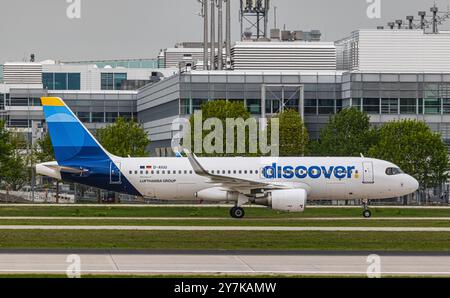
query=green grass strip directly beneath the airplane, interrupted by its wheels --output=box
[0,205,450,218]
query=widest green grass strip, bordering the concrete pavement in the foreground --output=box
[0,230,450,252]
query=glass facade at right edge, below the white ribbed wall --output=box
[343,73,450,115]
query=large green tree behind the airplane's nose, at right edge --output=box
[369,120,449,190]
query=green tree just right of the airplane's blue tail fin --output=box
[97,117,150,157]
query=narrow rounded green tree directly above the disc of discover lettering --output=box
[274,109,309,156]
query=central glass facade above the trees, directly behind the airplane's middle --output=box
[180,74,343,115]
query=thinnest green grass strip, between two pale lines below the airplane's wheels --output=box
[0,218,450,229]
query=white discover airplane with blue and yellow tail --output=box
[36,97,419,218]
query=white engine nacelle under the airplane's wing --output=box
[268,189,308,212]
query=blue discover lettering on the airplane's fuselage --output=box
[262,163,359,179]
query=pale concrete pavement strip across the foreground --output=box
[0,250,450,276]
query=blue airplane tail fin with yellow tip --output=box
[41,97,109,165]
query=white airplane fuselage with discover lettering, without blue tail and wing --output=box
[111,157,418,200]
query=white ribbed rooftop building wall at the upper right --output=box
[336,29,450,73]
